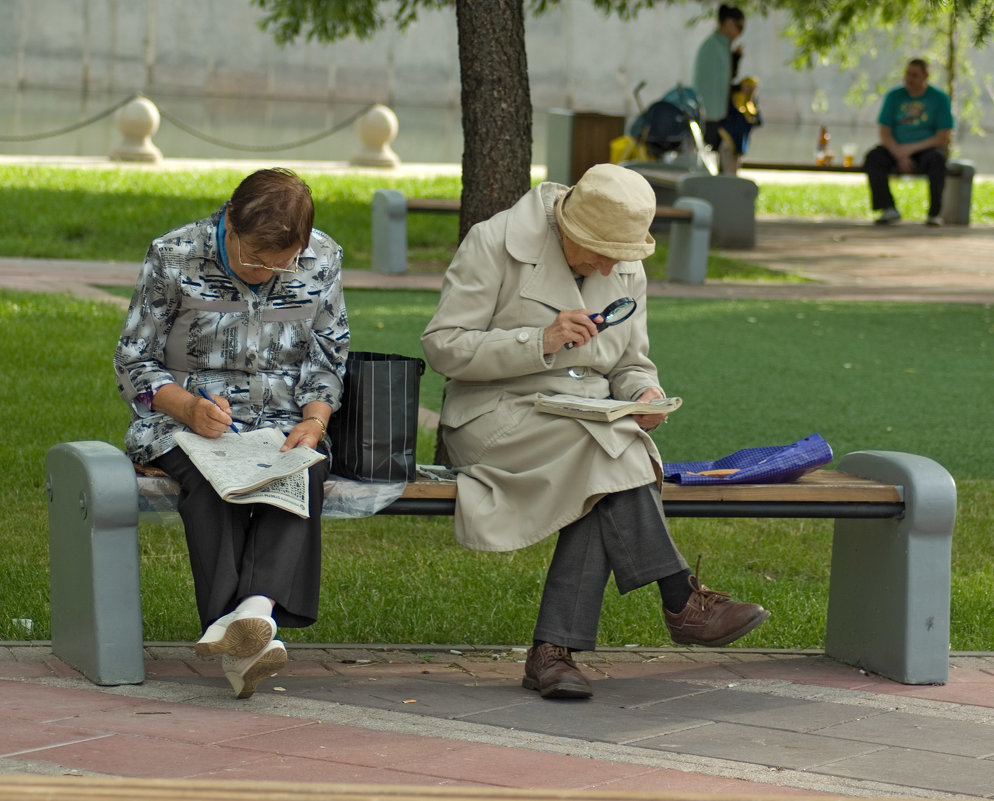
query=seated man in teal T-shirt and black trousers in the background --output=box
[864,58,954,225]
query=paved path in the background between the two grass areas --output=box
[0,219,994,304]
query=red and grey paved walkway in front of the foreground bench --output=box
[0,643,994,799]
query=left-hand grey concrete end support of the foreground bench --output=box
[45,442,145,684]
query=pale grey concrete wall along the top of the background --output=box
[0,0,994,125]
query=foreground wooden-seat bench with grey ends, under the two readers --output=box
[45,442,956,684]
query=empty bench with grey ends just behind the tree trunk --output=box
[372,189,712,284]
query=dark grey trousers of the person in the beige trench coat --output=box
[535,484,687,651]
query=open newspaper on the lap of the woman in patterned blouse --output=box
[175,428,325,518]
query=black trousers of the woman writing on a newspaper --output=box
[153,448,329,629]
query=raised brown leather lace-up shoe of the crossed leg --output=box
[663,576,770,648]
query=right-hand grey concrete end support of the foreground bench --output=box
[825,451,956,684]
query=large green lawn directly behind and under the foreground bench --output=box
[0,291,994,650]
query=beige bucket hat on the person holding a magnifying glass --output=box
[556,164,656,261]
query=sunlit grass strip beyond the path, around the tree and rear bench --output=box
[0,166,799,281]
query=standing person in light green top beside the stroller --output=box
[693,3,745,167]
